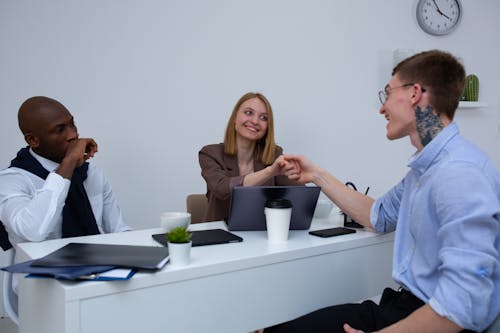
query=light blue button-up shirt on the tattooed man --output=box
[370,123,500,331]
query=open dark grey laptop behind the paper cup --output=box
[227,186,321,231]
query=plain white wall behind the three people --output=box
[0,0,500,228]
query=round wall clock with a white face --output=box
[417,0,462,36]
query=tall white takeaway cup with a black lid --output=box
[264,199,292,243]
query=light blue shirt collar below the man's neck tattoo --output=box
[408,122,459,174]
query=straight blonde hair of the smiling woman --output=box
[224,92,276,165]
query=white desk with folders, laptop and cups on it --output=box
[18,220,393,333]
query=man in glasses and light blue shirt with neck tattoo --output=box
[266,50,500,333]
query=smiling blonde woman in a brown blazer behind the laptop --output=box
[199,92,299,221]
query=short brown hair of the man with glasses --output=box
[392,50,465,119]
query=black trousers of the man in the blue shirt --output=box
[264,288,476,333]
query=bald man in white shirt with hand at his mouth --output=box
[0,96,130,249]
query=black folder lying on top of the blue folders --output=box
[32,243,168,270]
